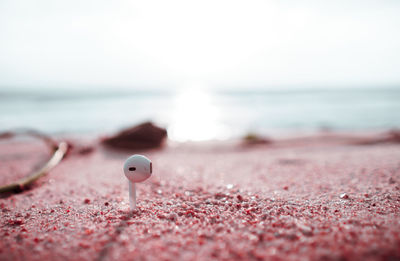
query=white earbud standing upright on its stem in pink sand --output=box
[124,155,153,210]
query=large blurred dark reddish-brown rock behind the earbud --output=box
[102,122,167,150]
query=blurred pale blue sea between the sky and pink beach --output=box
[0,88,400,141]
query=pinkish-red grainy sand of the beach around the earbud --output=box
[0,135,400,260]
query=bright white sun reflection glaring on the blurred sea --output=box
[168,88,226,141]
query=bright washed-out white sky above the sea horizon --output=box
[0,0,400,88]
